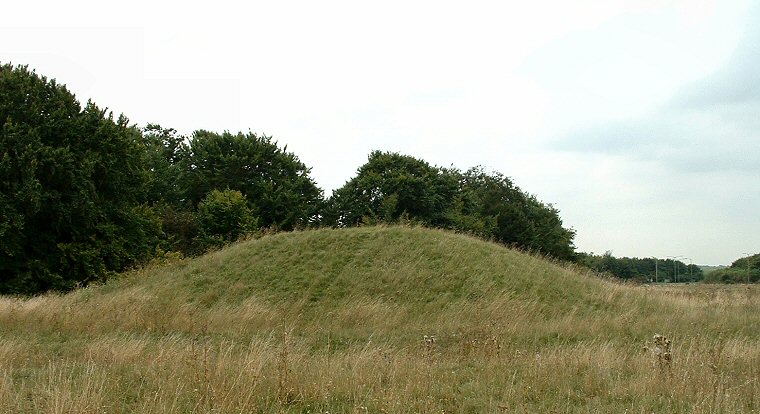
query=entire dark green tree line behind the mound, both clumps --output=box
[0,64,588,294]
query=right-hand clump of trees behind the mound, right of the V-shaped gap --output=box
[324,151,575,260]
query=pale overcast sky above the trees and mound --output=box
[0,0,760,264]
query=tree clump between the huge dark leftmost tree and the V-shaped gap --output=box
[138,124,323,255]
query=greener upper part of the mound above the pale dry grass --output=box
[114,227,624,313]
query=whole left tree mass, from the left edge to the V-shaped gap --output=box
[0,65,323,293]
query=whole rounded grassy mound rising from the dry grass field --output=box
[2,226,656,347]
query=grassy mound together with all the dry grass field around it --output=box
[0,227,760,413]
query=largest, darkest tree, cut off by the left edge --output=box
[0,65,160,293]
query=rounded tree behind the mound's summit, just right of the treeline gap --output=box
[324,151,457,227]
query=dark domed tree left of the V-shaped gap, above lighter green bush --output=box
[182,130,323,230]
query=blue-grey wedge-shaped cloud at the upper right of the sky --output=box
[551,2,760,174]
